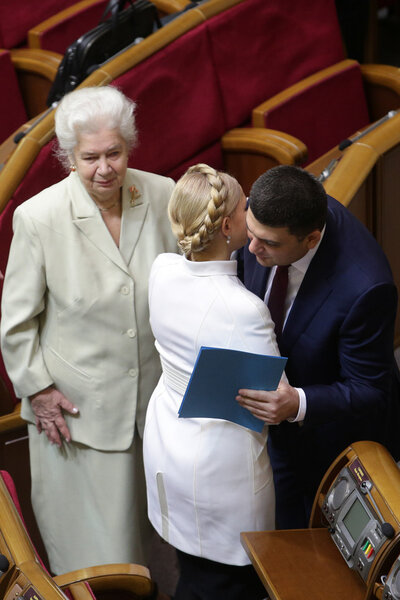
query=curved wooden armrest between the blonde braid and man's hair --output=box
[221,127,307,194]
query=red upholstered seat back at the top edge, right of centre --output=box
[205,0,344,129]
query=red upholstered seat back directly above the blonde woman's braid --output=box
[113,23,226,174]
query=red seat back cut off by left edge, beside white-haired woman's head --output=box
[0,50,28,144]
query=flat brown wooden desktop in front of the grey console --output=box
[241,529,366,600]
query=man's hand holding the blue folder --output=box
[236,381,299,425]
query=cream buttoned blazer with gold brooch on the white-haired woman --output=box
[1,169,176,450]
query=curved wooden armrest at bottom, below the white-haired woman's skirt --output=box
[54,563,155,598]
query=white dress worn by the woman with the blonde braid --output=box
[144,254,279,565]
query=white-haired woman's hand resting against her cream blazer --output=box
[30,386,79,447]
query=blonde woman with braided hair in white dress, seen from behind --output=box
[144,164,278,600]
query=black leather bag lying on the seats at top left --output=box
[47,0,161,106]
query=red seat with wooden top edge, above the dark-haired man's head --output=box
[253,60,370,162]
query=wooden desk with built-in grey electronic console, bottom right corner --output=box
[242,442,400,600]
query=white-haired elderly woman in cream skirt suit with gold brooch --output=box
[1,87,176,573]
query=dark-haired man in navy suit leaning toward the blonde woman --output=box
[237,166,400,528]
